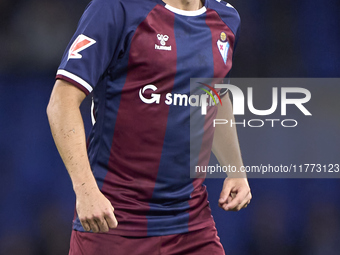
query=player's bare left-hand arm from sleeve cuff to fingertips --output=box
[47,80,118,232]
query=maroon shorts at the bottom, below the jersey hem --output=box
[69,226,225,255]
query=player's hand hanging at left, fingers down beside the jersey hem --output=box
[76,185,118,233]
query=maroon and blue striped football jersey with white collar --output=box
[57,0,240,236]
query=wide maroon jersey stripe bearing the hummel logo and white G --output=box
[102,5,177,235]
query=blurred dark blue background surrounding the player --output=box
[0,0,340,255]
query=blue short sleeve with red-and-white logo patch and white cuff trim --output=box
[56,0,124,95]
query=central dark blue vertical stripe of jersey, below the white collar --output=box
[147,11,213,235]
